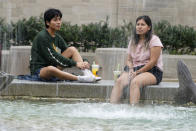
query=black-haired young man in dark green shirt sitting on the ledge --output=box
[30,9,101,82]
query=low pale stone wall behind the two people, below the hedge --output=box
[1,46,196,82]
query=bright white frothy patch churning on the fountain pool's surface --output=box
[68,103,186,121]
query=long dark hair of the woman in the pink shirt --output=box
[132,15,152,49]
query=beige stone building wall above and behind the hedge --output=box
[0,0,196,28]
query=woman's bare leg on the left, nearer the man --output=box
[110,72,129,103]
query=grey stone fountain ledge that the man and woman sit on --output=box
[0,79,179,102]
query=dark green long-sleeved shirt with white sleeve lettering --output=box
[30,30,76,74]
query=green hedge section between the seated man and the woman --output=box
[59,19,132,52]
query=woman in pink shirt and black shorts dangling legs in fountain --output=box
[110,16,163,104]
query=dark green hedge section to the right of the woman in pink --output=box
[154,21,196,54]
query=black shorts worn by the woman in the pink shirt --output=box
[124,65,163,85]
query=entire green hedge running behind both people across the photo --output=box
[0,16,196,55]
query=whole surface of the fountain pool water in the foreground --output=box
[0,100,196,131]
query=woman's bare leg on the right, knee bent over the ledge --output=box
[130,72,157,104]
